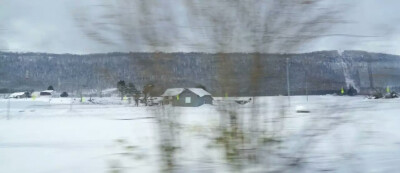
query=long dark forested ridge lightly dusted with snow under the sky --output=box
[0,51,400,96]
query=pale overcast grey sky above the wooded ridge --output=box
[0,0,400,54]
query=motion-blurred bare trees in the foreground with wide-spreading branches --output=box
[75,0,360,172]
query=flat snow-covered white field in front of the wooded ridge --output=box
[0,96,400,173]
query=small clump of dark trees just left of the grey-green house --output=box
[117,80,154,106]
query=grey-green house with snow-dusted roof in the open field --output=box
[161,88,213,107]
